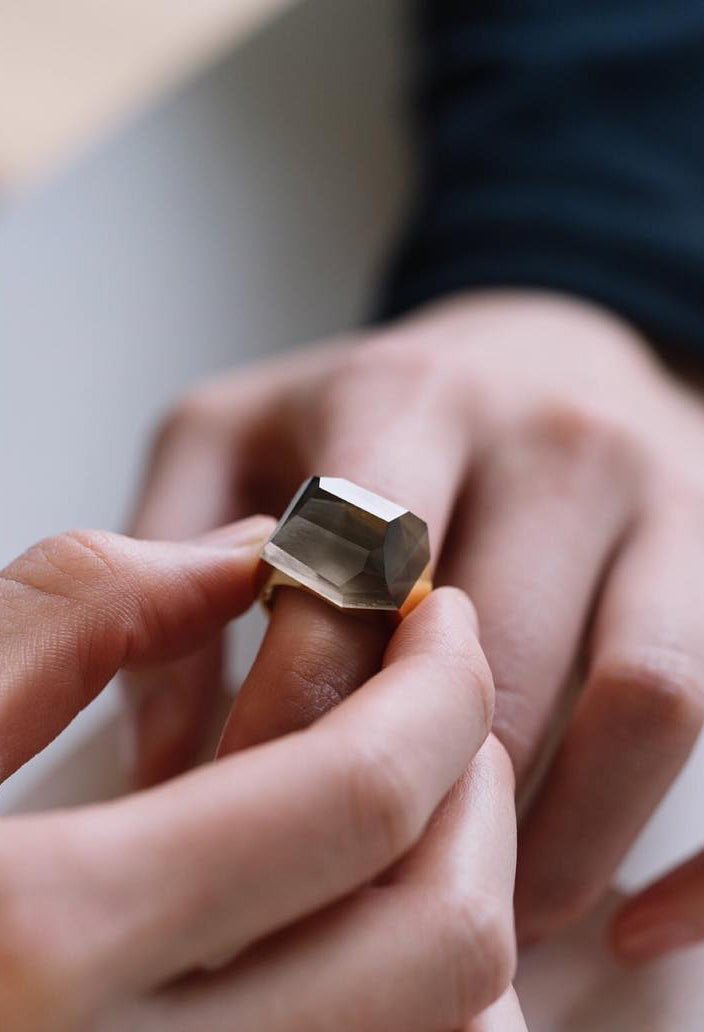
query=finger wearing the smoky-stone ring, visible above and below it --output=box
[220,346,471,752]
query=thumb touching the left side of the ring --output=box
[0,517,271,778]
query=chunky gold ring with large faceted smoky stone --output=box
[259,477,433,620]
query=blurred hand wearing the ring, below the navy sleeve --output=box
[129,291,704,938]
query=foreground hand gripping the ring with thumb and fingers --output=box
[0,519,524,1032]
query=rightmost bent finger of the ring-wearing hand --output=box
[516,504,704,938]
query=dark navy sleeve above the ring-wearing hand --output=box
[382,0,704,360]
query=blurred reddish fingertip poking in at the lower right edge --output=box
[611,853,704,964]
